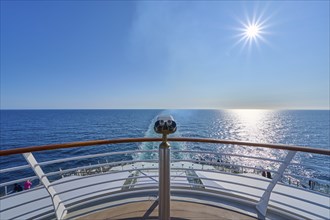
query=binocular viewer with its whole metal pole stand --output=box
[154,115,176,220]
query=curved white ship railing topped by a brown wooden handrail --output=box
[0,138,330,219]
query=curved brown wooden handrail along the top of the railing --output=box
[0,137,330,156]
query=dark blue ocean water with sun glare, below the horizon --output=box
[0,110,330,186]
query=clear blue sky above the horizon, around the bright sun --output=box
[1,1,329,109]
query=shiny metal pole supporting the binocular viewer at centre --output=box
[158,134,171,220]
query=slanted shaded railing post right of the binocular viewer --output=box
[256,151,296,218]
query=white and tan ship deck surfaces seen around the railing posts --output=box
[0,162,330,219]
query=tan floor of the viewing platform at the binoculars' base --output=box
[79,201,255,220]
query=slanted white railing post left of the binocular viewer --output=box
[23,153,67,219]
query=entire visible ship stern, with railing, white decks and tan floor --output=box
[0,138,330,220]
